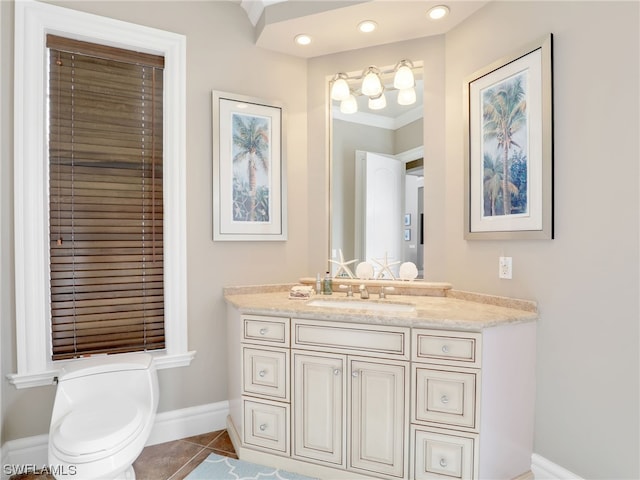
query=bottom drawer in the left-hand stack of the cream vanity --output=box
[243,398,289,455]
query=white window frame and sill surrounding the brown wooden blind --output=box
[8,2,195,388]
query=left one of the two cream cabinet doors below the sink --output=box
[293,351,346,467]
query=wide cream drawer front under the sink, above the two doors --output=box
[293,319,410,360]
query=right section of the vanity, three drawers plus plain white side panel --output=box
[410,323,535,480]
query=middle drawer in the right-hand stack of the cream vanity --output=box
[412,365,479,428]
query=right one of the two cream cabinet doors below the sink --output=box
[349,357,409,478]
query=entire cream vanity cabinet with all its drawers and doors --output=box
[227,293,536,480]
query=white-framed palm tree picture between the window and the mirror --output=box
[212,90,287,241]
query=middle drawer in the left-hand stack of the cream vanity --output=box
[242,346,289,401]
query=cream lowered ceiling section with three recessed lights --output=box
[240,0,488,58]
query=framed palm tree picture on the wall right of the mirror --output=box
[464,34,553,240]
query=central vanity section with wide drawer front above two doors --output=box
[291,319,410,478]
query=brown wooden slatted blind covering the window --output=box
[47,35,165,360]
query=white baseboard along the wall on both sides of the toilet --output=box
[0,400,229,479]
